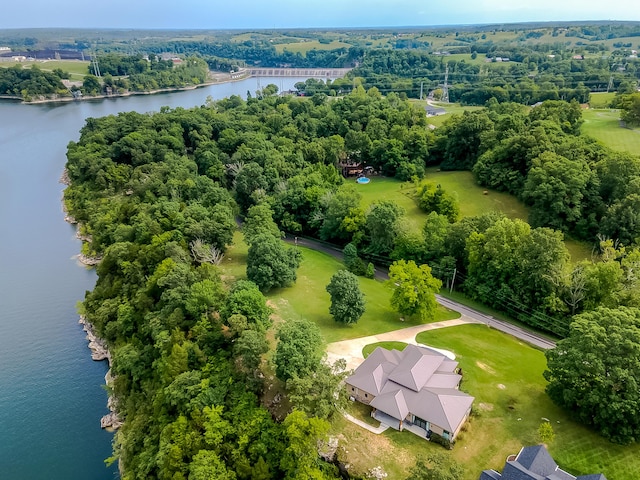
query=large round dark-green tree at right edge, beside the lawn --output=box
[544,307,640,443]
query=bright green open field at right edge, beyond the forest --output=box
[582,110,640,155]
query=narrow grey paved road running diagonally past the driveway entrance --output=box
[284,234,556,350]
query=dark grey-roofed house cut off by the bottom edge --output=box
[480,445,607,480]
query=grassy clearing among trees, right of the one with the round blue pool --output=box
[426,168,529,220]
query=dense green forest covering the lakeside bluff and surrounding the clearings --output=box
[65,86,640,479]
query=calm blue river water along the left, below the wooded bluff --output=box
[0,78,304,480]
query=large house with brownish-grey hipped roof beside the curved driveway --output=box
[345,345,473,441]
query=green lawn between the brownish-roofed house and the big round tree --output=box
[408,325,640,480]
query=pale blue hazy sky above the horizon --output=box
[0,0,640,29]
